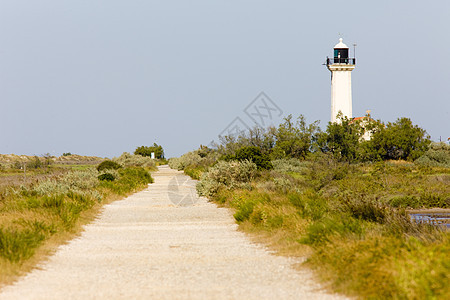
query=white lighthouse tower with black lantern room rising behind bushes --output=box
[327,38,356,122]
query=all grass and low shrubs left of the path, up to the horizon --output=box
[0,153,155,285]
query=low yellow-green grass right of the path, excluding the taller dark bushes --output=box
[186,156,450,299]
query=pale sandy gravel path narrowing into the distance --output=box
[0,167,348,300]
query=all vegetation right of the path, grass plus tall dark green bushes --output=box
[169,117,450,299]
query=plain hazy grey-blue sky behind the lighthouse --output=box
[0,0,450,157]
